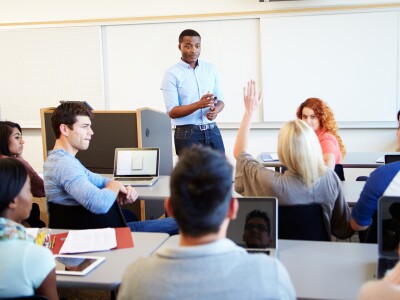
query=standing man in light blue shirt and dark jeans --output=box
[161,29,225,155]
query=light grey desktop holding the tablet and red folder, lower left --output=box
[53,230,169,291]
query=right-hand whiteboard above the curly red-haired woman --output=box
[260,12,399,127]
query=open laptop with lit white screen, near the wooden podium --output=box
[114,148,160,186]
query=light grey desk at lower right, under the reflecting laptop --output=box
[161,236,378,299]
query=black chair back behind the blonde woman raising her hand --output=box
[278,203,331,241]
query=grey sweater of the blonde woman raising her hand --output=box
[235,153,354,239]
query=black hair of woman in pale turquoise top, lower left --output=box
[0,157,28,214]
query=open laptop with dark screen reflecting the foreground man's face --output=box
[227,197,278,256]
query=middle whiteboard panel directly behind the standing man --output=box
[103,19,260,122]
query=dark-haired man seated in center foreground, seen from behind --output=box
[118,146,295,300]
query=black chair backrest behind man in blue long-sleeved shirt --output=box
[47,201,127,229]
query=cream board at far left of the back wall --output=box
[0,26,104,128]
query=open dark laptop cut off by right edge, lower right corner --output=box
[377,196,400,278]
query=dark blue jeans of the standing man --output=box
[174,123,225,155]
